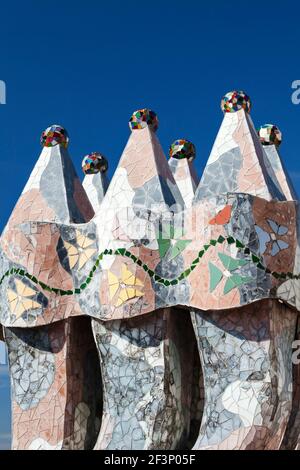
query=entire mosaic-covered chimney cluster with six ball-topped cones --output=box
[0,91,300,450]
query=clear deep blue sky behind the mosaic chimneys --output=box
[0,0,300,448]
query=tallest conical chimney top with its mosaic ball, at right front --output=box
[194,91,285,203]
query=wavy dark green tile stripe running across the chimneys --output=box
[0,235,300,295]
